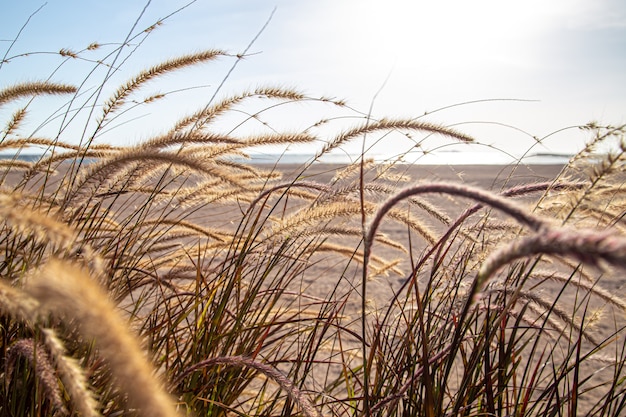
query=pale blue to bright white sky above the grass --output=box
[0,0,626,162]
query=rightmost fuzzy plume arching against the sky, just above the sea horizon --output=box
[316,119,474,158]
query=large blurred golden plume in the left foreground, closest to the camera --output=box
[27,260,177,417]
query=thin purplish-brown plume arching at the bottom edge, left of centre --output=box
[174,356,321,417]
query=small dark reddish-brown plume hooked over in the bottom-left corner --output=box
[5,339,68,415]
